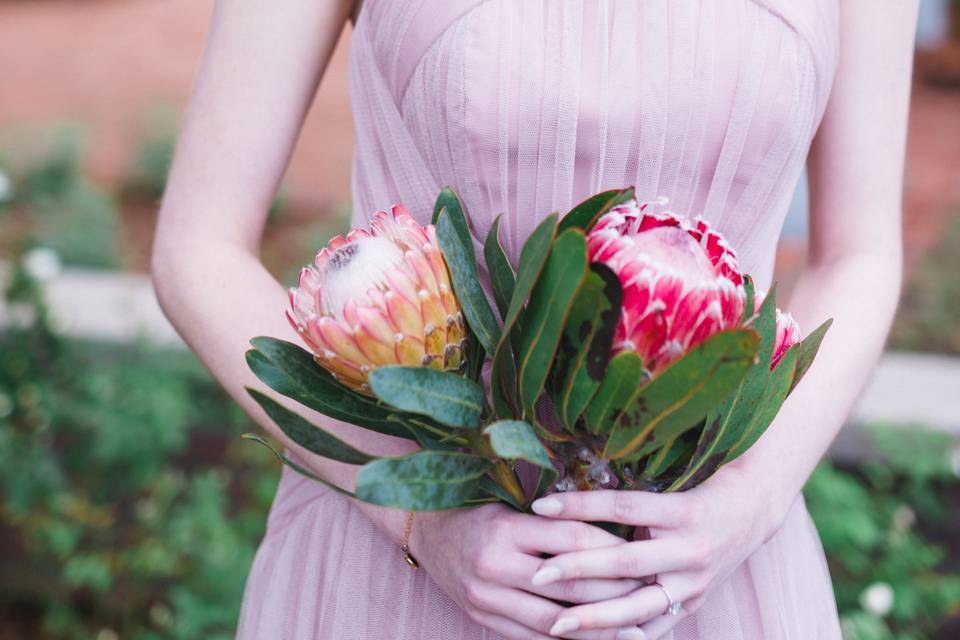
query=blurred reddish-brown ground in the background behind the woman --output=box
[0,0,960,262]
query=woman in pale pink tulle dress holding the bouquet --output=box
[154,0,917,640]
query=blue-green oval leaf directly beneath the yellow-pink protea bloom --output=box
[368,366,484,428]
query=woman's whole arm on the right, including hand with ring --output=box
[534,0,917,640]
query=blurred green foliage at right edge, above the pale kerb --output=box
[890,213,960,354]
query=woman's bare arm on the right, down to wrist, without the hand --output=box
[738,0,918,515]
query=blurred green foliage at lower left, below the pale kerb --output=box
[0,252,277,640]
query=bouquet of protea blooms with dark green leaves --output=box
[247,188,830,510]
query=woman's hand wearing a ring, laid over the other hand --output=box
[533,466,789,640]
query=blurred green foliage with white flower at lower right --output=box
[805,427,960,640]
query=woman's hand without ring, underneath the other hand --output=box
[410,505,640,640]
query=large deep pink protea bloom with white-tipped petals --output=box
[587,201,746,375]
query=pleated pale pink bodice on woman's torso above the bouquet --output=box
[350,0,837,286]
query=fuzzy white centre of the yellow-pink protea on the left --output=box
[320,236,403,319]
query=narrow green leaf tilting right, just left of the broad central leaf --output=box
[490,213,557,418]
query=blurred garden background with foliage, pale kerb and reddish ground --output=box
[0,0,960,640]
